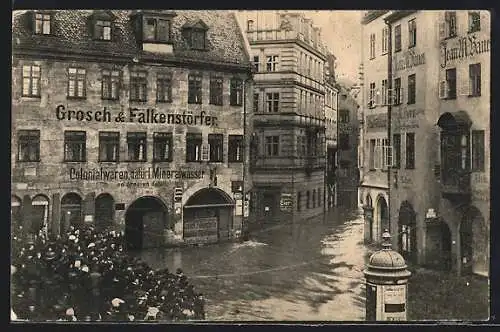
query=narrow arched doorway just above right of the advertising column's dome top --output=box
[398,201,417,263]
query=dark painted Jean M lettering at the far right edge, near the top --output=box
[441,35,491,68]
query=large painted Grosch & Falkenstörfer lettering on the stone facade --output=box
[56,105,218,127]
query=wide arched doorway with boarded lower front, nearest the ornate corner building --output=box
[183,188,234,243]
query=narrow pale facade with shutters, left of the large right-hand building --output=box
[359,10,389,242]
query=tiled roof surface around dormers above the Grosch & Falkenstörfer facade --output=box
[12,10,250,66]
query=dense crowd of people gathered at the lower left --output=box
[11,225,205,321]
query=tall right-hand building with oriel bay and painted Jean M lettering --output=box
[367,11,490,275]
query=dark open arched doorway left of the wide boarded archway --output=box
[125,196,168,250]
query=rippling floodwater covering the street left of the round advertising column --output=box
[140,211,366,321]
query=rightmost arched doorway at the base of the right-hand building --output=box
[460,206,489,275]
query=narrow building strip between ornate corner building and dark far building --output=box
[325,53,338,209]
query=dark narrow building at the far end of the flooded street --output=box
[337,85,360,208]
